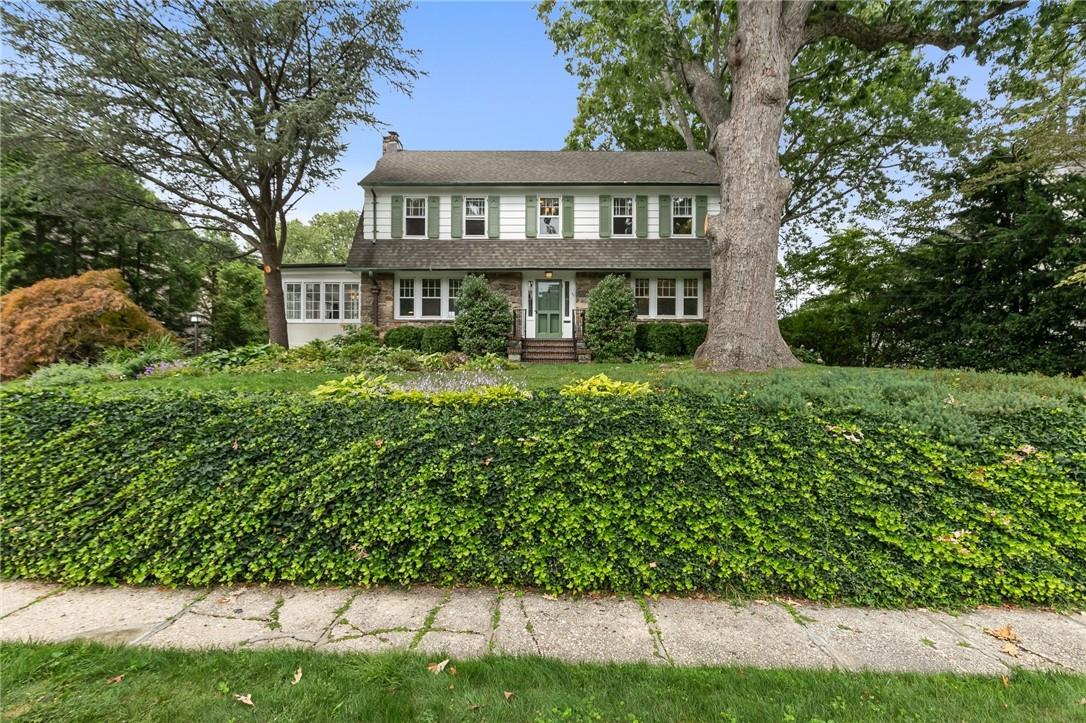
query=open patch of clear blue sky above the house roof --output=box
[292,0,578,220]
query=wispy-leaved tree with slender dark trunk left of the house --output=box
[0,0,417,345]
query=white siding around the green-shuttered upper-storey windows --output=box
[366,186,720,241]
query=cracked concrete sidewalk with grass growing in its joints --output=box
[0,581,1086,675]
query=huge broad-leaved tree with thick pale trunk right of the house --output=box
[540,0,1025,370]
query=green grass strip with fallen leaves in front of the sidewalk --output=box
[0,643,1086,723]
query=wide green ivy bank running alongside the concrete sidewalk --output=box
[0,390,1086,606]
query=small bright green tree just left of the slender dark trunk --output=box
[211,261,267,348]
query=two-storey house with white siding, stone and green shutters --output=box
[283,132,720,358]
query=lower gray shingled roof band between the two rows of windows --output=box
[346,238,709,271]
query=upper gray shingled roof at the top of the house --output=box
[359,151,720,186]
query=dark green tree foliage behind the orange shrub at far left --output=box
[0,144,238,330]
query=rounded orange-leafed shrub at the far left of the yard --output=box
[0,269,165,379]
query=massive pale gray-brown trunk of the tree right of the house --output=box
[695,2,799,371]
